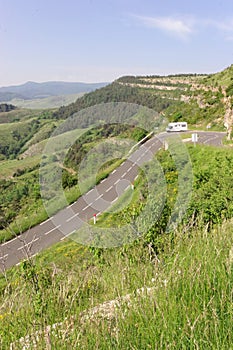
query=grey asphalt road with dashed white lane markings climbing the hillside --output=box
[0,131,225,272]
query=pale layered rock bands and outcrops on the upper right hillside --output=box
[119,74,233,133]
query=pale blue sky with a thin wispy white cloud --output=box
[0,0,233,86]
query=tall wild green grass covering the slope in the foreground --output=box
[0,223,233,349]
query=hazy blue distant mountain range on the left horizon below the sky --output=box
[0,81,108,102]
